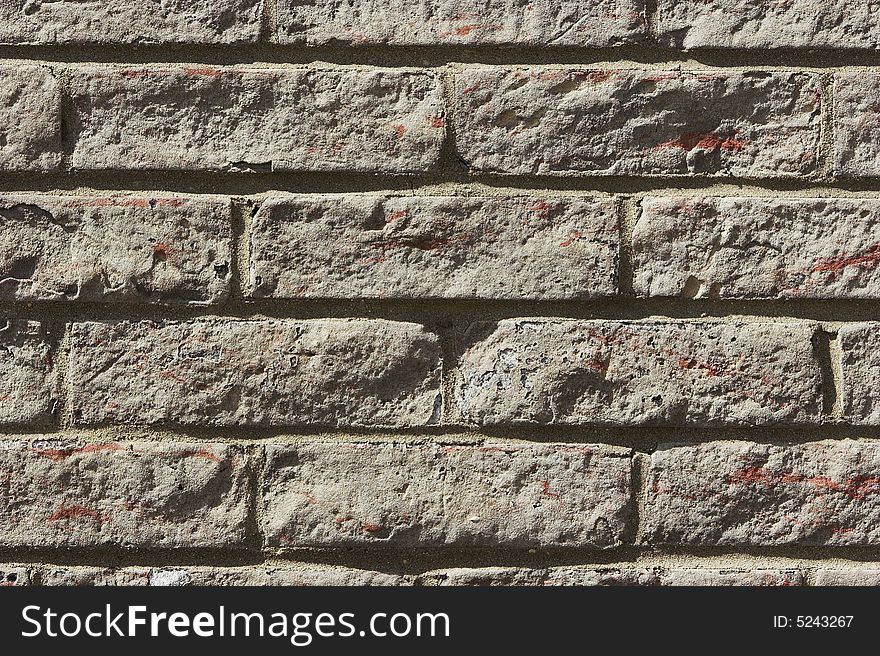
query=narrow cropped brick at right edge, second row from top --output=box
[834,71,880,178]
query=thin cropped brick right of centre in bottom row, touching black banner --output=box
[421,567,803,586]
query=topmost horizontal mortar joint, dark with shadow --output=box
[6,42,880,70]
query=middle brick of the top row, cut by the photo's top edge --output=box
[278,0,647,47]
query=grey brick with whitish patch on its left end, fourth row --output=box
[455,319,820,426]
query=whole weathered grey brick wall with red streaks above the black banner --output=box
[0,0,880,585]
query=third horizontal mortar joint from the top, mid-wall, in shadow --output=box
[0,296,880,322]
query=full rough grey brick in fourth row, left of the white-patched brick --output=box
[70,319,440,428]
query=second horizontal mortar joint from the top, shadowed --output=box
[0,170,880,200]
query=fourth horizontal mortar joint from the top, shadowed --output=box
[0,422,880,456]
